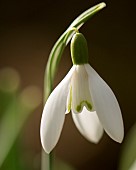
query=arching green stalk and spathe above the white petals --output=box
[44,2,106,98]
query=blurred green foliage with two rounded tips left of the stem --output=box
[0,68,41,170]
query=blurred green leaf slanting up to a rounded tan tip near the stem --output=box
[0,86,41,167]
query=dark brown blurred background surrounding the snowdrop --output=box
[0,0,136,170]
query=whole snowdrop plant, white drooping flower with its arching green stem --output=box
[40,2,124,170]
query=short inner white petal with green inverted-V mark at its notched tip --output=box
[71,65,93,113]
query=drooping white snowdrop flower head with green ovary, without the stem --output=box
[40,33,124,153]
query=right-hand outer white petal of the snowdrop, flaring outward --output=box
[85,64,124,143]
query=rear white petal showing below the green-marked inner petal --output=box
[72,107,103,143]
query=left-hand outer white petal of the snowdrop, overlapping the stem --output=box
[40,66,74,153]
